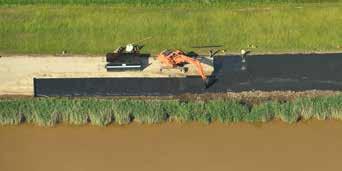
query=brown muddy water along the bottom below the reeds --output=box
[0,121,342,171]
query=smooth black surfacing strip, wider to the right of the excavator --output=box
[34,53,342,96]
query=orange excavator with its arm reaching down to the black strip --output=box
[157,50,208,87]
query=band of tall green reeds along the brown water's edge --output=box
[0,95,342,126]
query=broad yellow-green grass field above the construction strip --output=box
[0,2,342,54]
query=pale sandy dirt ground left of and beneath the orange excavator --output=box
[0,56,213,95]
